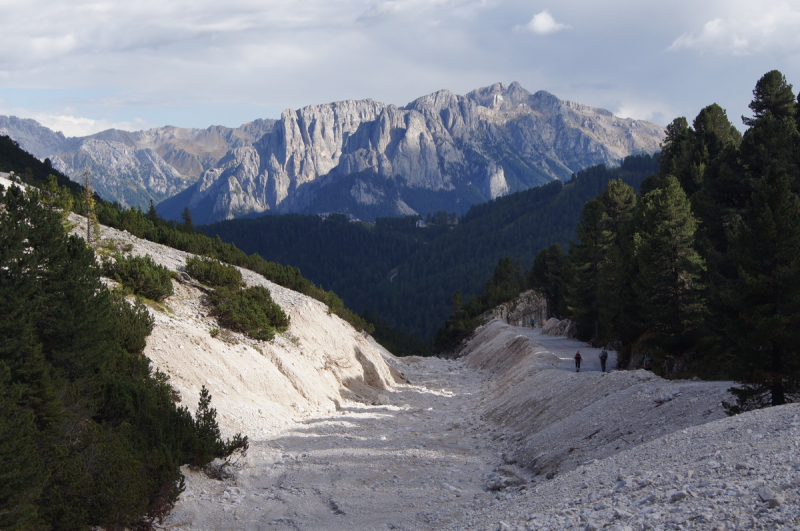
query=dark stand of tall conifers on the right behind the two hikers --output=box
[532,70,800,411]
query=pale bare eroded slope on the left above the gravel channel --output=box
[61,210,405,439]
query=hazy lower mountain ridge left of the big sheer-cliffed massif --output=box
[0,116,275,206]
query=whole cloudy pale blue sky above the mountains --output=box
[0,0,800,136]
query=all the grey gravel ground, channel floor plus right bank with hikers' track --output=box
[159,322,800,530]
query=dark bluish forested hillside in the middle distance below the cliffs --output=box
[201,155,658,340]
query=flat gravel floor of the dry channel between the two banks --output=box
[167,358,500,530]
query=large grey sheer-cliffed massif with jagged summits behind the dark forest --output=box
[159,83,664,223]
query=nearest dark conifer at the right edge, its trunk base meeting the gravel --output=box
[727,168,800,409]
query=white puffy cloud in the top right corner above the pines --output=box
[667,2,800,56]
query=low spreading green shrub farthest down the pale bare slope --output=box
[209,286,289,341]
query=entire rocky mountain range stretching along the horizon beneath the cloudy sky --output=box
[0,82,664,223]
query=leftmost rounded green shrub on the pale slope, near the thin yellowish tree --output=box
[103,254,173,302]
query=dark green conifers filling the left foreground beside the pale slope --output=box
[0,186,248,529]
